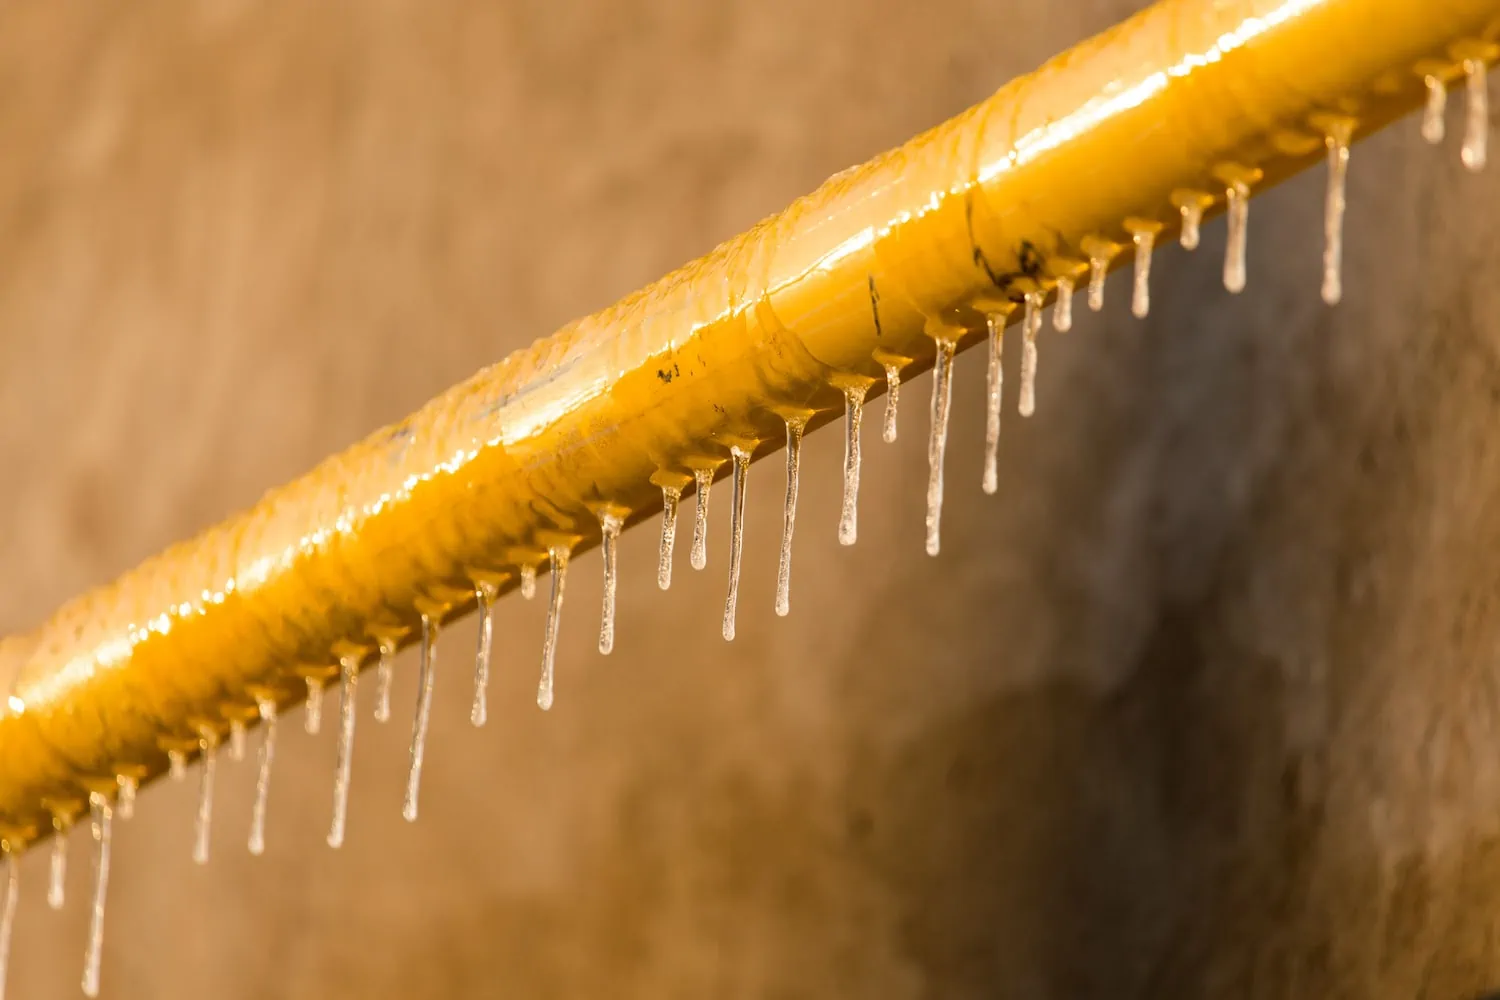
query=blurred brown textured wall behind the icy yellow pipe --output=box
[0,0,1500,1000]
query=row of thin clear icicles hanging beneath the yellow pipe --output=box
[0,60,1490,1000]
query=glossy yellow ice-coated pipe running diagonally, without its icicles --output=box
[0,0,1500,846]
